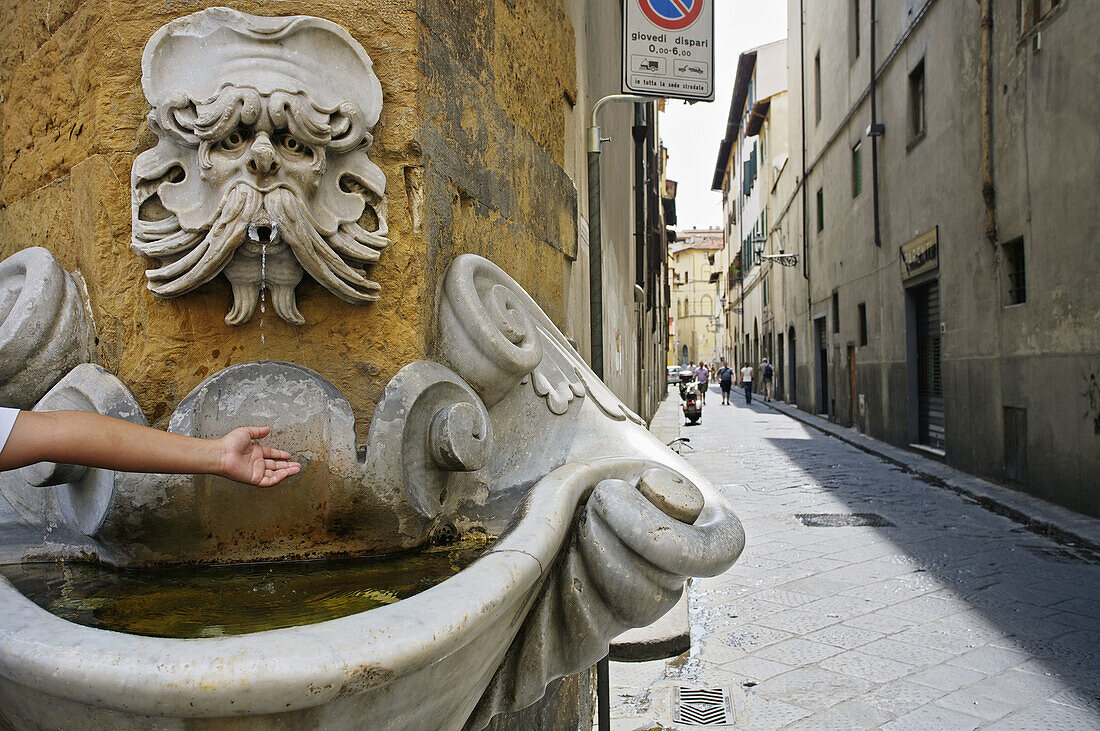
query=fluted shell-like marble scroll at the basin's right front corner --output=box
[465,458,745,731]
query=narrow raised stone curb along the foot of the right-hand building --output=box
[755,399,1100,552]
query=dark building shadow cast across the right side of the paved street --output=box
[756,433,1100,703]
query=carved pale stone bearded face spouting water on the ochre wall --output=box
[131,8,389,325]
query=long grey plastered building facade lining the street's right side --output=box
[708,0,1100,514]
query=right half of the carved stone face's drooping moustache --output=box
[264,188,381,304]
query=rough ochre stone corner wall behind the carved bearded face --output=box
[0,0,576,439]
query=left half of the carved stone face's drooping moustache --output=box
[142,184,263,297]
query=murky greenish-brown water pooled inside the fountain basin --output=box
[0,533,487,639]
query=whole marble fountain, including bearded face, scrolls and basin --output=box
[0,9,745,729]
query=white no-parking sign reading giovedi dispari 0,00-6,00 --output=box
[623,0,714,101]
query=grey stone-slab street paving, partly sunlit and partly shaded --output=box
[611,384,1100,730]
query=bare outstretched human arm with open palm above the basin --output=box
[0,411,301,487]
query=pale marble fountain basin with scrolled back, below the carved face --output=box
[0,248,745,730]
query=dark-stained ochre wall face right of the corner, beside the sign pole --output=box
[418,0,578,338]
